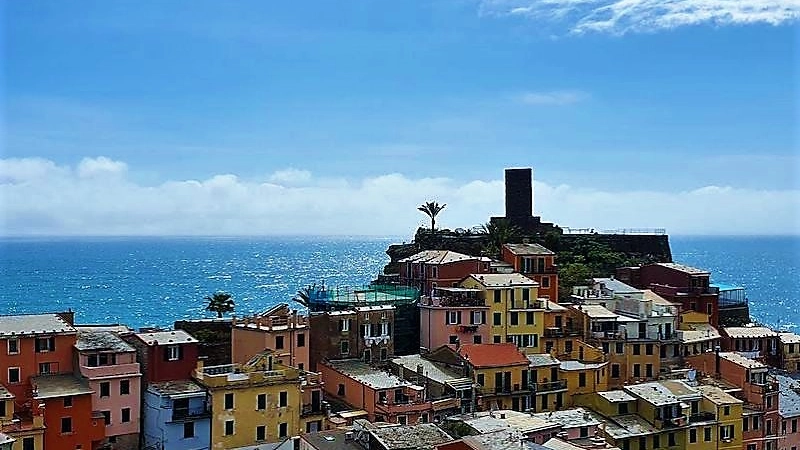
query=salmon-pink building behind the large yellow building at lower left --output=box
[231,303,310,370]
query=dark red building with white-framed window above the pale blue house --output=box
[123,330,199,383]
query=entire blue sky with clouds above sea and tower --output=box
[0,0,800,236]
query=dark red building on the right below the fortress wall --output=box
[616,263,719,327]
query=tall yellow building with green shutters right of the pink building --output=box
[461,273,549,354]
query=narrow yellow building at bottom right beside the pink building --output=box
[692,385,744,450]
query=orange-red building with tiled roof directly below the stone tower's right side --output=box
[502,244,558,301]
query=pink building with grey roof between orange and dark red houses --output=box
[75,331,142,450]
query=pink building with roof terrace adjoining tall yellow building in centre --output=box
[419,287,490,349]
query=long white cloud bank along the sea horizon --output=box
[0,156,800,236]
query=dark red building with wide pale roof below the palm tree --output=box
[399,250,491,295]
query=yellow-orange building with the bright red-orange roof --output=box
[456,343,531,411]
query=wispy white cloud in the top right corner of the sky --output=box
[481,0,800,35]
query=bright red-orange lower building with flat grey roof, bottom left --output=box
[31,374,105,450]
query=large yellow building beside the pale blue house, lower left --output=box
[194,352,305,449]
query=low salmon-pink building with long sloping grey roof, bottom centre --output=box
[317,359,433,425]
